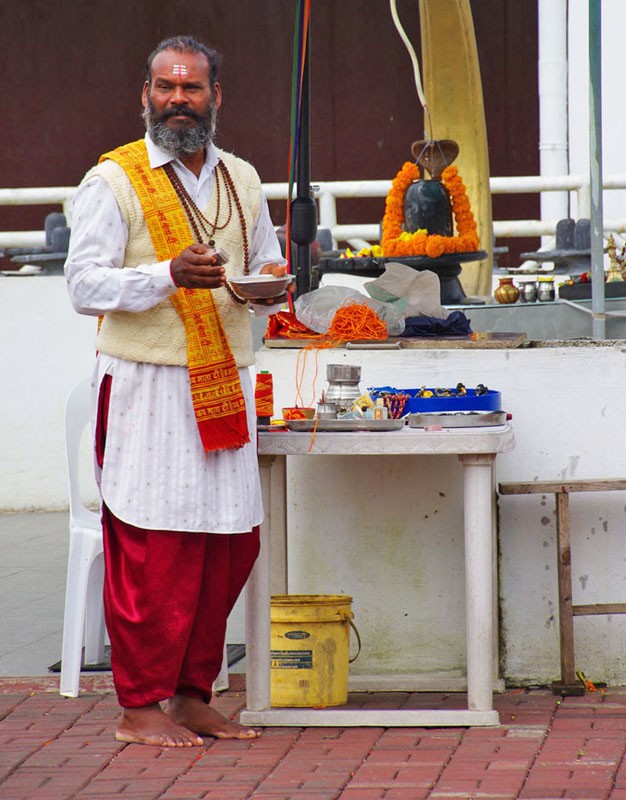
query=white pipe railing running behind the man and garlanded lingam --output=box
[0,175,626,248]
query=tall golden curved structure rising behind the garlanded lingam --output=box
[419,0,493,296]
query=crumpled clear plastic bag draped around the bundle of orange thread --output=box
[294,286,404,336]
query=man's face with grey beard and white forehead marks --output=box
[142,50,222,157]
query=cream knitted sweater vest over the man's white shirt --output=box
[90,150,261,367]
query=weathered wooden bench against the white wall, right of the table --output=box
[498,478,626,695]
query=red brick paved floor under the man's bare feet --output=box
[0,675,626,800]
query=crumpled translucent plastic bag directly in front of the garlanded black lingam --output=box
[365,261,448,319]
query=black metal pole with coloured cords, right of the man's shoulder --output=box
[291,23,317,295]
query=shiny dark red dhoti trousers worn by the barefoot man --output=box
[96,376,259,708]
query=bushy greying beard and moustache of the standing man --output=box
[142,98,217,158]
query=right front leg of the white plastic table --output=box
[459,453,495,711]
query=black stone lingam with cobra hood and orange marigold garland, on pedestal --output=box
[318,139,487,305]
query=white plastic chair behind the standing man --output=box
[59,378,229,697]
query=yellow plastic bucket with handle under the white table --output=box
[270,594,361,707]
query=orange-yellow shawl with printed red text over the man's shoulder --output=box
[100,139,250,452]
